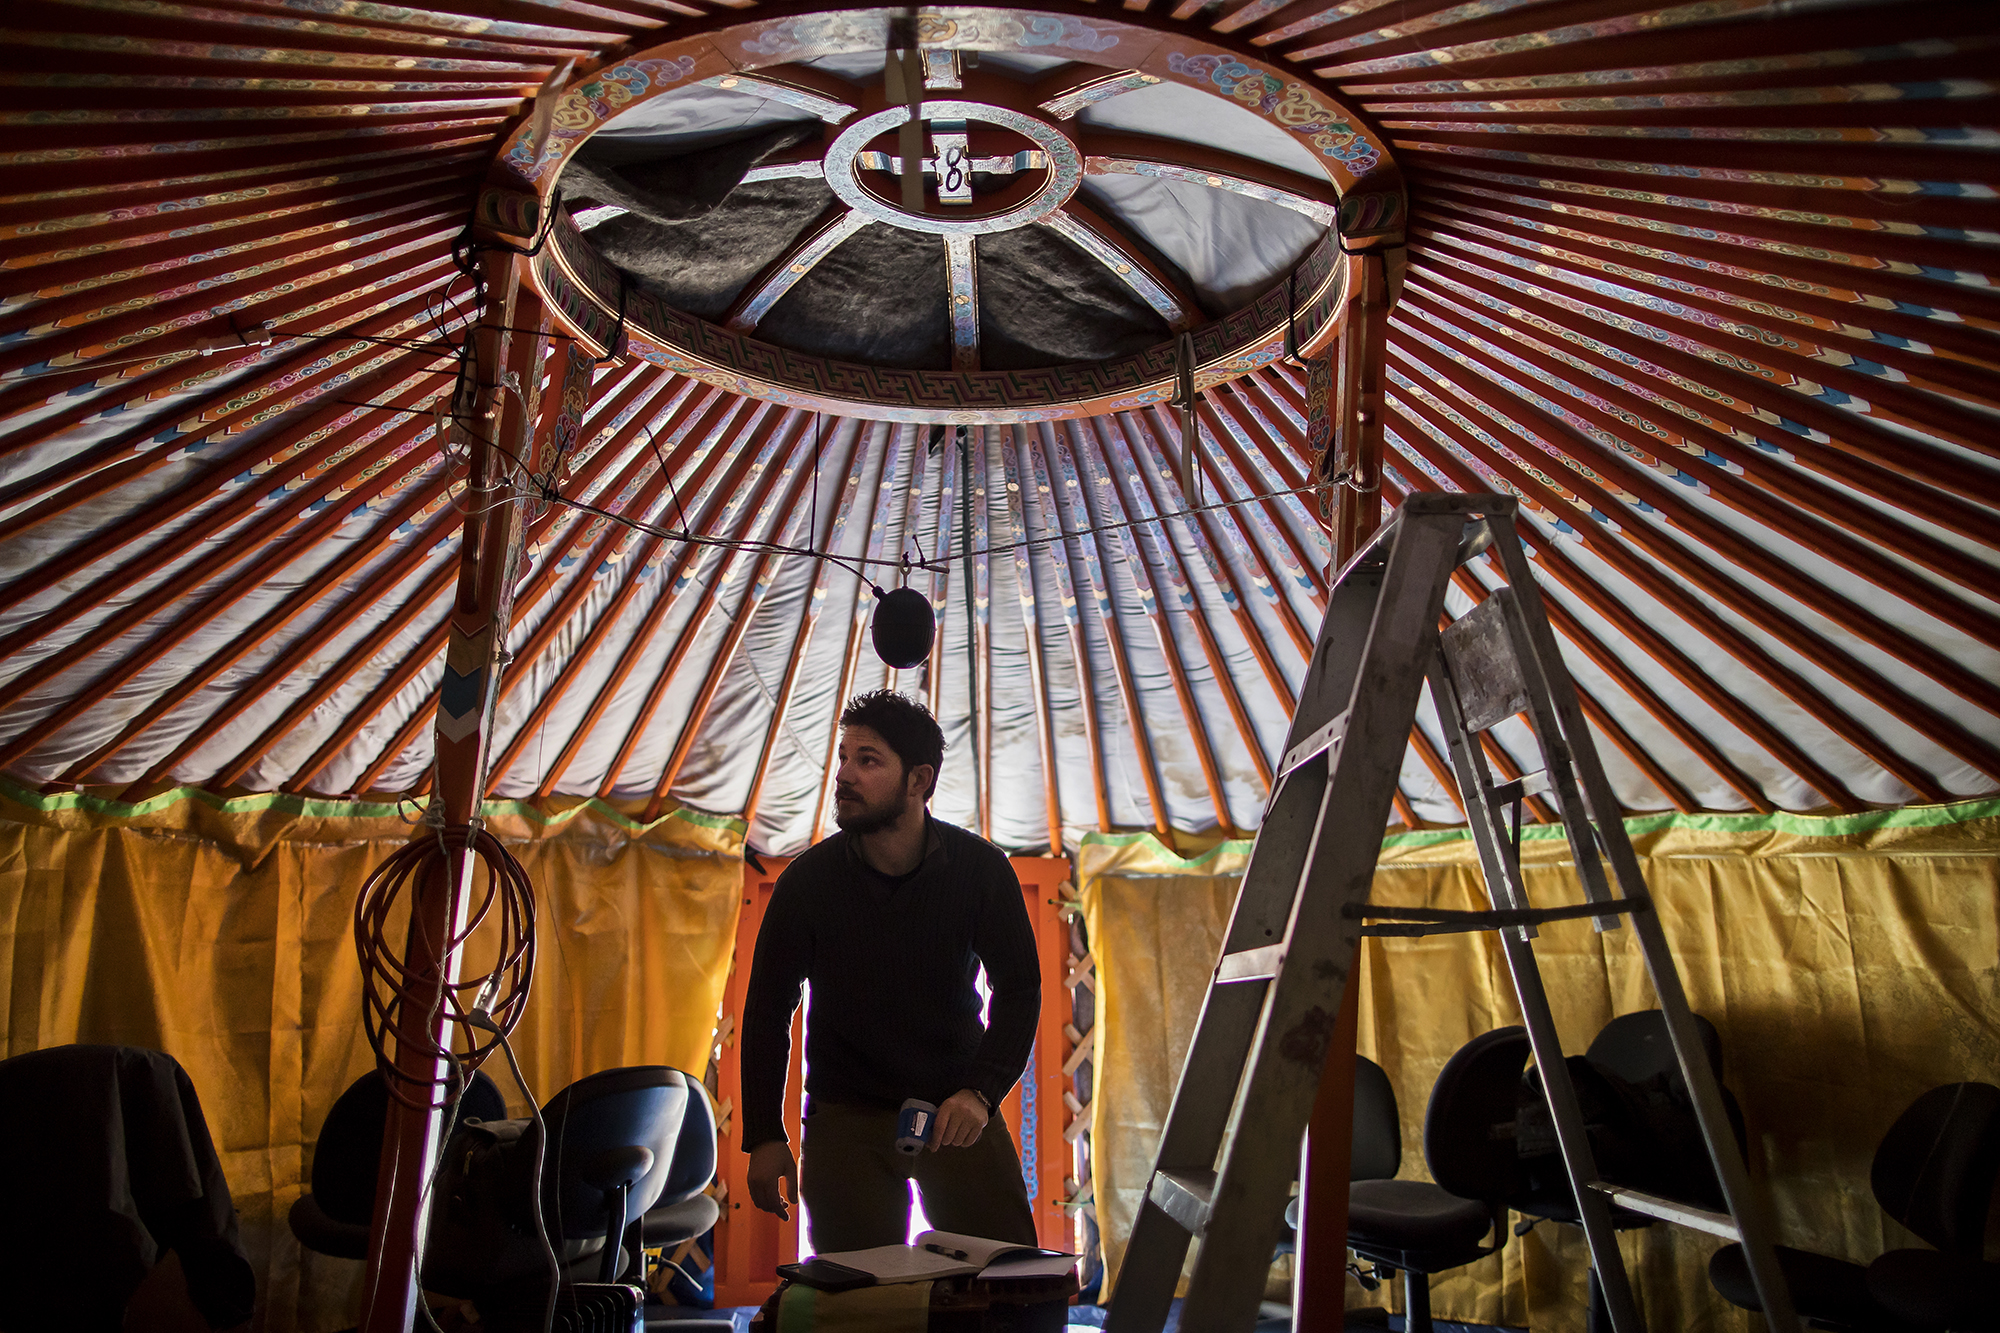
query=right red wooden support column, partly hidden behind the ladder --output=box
[1292,239,1390,1333]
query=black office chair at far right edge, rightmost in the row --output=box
[1708,1083,2000,1333]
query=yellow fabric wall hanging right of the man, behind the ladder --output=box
[1078,801,2000,1333]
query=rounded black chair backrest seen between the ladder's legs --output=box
[1424,1027,1528,1203]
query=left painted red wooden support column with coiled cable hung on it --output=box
[362,248,546,1333]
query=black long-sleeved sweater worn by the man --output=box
[742,819,1042,1149]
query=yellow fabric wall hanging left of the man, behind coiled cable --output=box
[0,785,742,1333]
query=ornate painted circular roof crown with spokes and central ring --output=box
[480,8,1402,422]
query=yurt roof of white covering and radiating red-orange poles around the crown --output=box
[0,0,2000,853]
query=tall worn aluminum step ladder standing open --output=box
[1106,494,1798,1333]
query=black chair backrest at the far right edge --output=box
[1868,1083,2000,1259]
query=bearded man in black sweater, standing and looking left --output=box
[742,691,1042,1253]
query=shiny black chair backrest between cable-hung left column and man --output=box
[542,1065,692,1241]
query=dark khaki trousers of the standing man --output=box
[798,1103,1038,1253]
